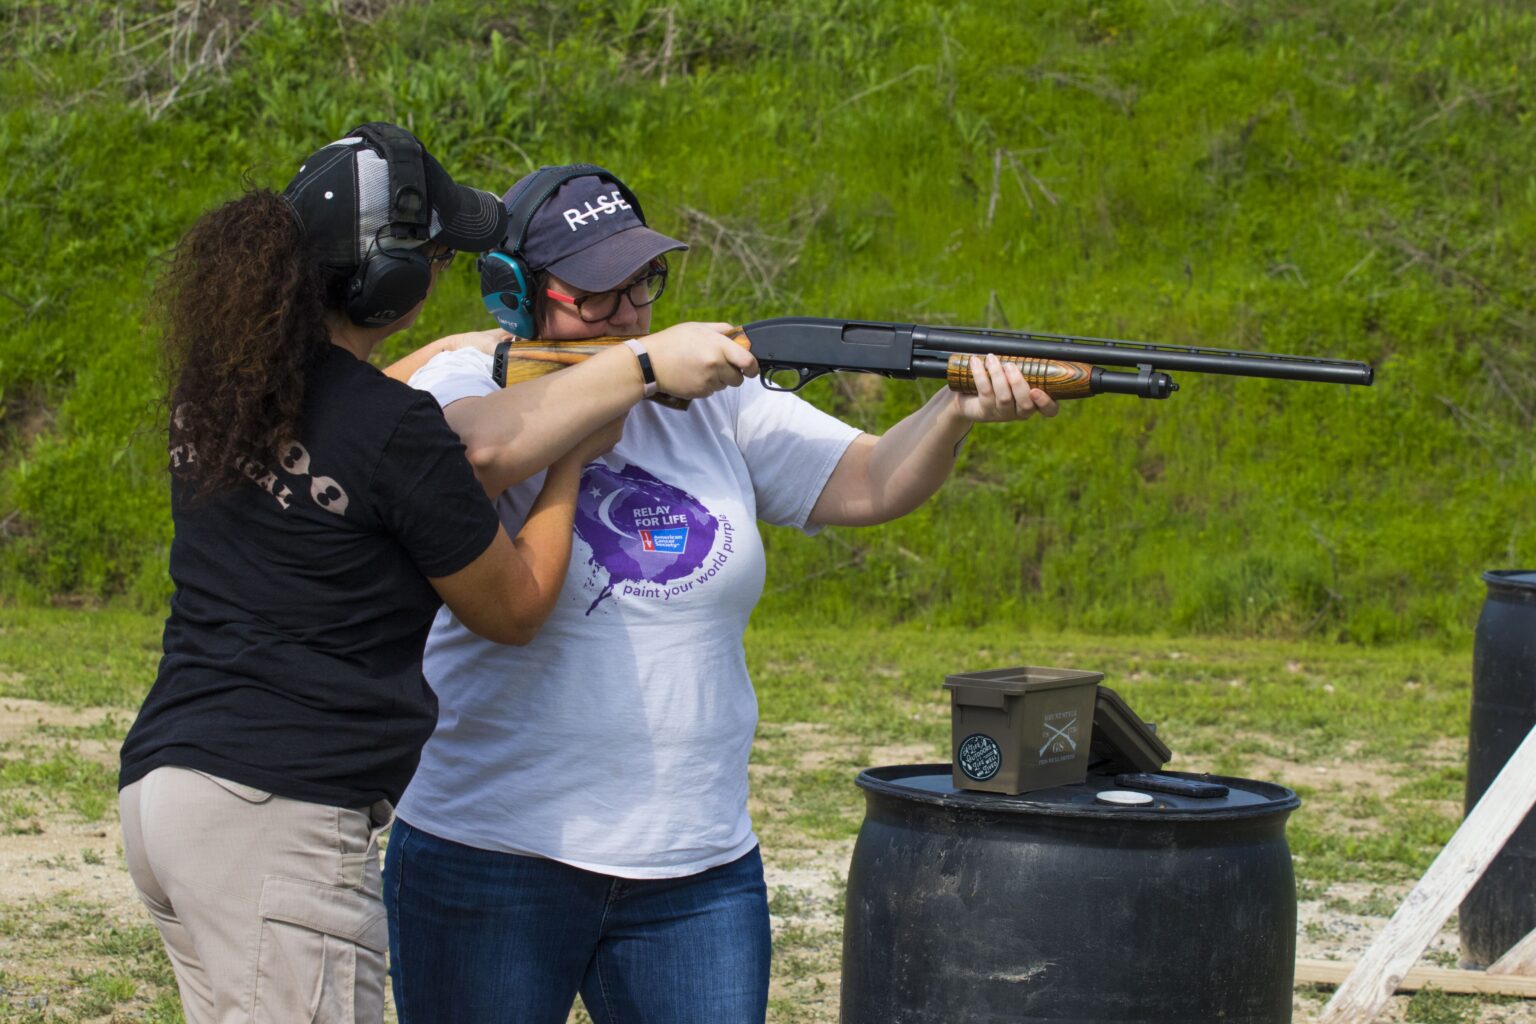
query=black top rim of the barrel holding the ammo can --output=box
[854,761,1301,823]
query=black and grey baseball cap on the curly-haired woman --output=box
[283,123,507,267]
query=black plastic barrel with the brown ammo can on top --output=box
[842,765,1299,1024]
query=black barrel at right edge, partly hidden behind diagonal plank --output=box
[1459,570,1536,967]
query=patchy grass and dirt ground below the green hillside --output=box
[0,608,1517,1024]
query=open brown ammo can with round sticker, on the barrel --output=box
[945,665,1104,795]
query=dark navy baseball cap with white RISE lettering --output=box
[502,175,688,292]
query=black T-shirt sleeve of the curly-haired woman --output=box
[373,395,501,576]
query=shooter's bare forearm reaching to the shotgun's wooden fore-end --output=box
[811,391,971,527]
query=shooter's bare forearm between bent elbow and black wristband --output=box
[444,345,645,496]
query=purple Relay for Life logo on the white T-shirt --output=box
[576,462,731,614]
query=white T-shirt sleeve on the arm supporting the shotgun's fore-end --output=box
[736,381,863,533]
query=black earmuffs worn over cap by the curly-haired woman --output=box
[347,121,432,327]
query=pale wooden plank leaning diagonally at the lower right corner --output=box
[1318,729,1536,1024]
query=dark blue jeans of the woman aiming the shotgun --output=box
[384,820,773,1024]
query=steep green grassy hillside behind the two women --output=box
[0,0,1536,645]
